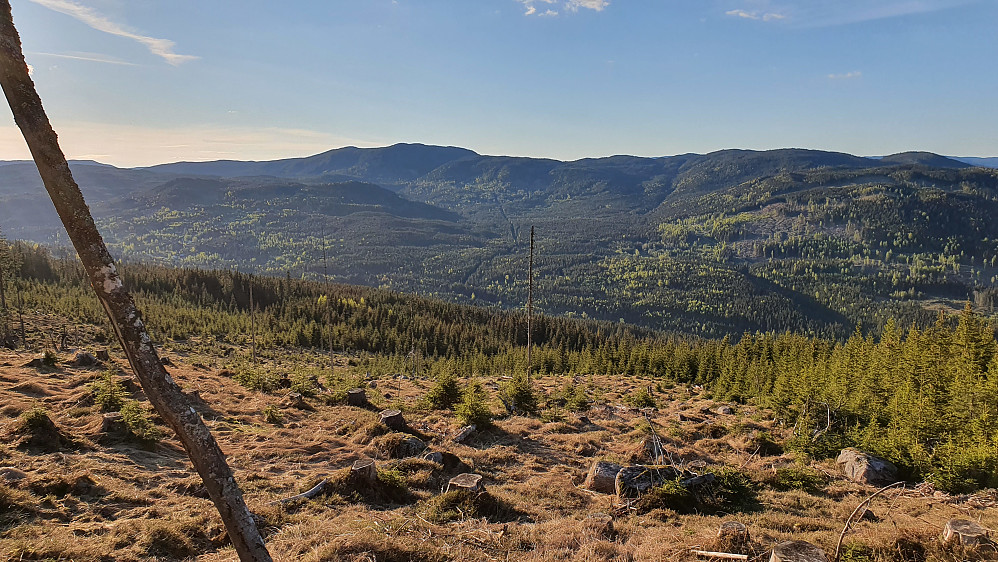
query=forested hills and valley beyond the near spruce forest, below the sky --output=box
[0,145,998,335]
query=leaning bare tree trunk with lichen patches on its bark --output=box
[0,0,271,562]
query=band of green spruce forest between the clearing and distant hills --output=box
[0,243,998,491]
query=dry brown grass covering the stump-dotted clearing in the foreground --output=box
[0,342,998,562]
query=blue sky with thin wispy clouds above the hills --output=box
[0,0,998,165]
